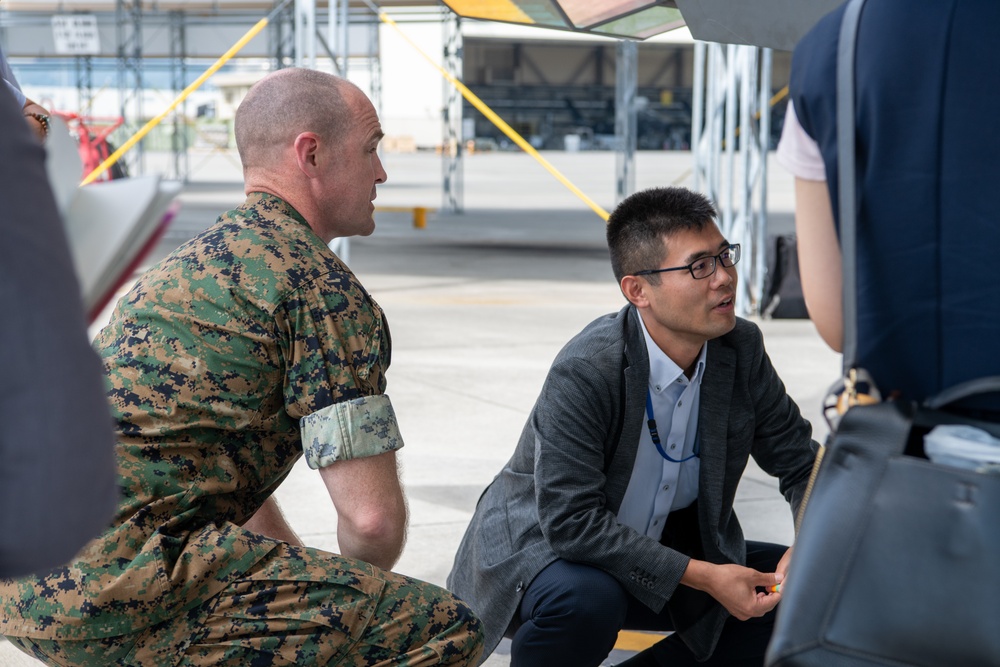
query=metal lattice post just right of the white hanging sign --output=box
[115,0,145,176]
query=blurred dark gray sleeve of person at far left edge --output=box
[0,88,118,577]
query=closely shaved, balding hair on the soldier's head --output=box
[235,68,355,169]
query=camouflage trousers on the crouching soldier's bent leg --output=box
[8,545,483,667]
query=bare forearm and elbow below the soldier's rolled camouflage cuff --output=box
[319,451,407,570]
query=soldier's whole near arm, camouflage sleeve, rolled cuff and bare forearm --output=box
[277,281,407,570]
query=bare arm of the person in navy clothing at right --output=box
[795,177,844,352]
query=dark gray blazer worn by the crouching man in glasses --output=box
[448,306,817,659]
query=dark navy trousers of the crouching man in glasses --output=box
[510,542,788,667]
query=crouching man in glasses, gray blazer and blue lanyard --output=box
[448,188,817,667]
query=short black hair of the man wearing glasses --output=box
[607,188,718,283]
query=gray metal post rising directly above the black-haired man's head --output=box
[615,39,639,203]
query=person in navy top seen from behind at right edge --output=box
[778,0,1000,414]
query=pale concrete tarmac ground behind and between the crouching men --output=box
[0,153,839,667]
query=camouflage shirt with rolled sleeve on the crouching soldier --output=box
[0,193,402,639]
